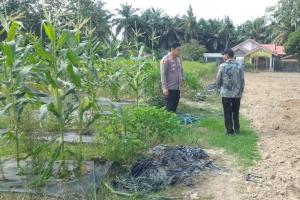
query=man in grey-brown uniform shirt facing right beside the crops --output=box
[160,42,183,112]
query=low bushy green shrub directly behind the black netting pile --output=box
[99,107,180,162]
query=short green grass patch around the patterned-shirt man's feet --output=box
[172,108,260,167]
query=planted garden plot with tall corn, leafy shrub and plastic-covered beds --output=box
[0,16,219,199]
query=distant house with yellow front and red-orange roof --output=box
[232,39,299,71]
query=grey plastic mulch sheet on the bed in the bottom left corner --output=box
[0,159,111,199]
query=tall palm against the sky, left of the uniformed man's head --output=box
[113,3,139,40]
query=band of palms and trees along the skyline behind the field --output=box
[0,0,300,54]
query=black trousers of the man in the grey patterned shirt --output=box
[222,98,241,133]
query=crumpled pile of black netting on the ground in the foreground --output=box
[112,145,216,193]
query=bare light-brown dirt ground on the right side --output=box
[185,73,300,200]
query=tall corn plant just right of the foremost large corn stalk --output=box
[62,28,101,143]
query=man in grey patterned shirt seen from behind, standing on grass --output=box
[217,49,245,134]
